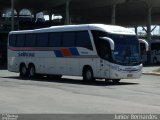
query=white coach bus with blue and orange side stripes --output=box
[8,24,148,82]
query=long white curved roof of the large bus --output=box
[10,24,135,35]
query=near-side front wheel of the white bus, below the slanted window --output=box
[83,67,95,82]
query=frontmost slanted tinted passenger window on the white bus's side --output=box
[76,31,93,50]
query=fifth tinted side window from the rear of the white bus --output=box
[49,32,61,47]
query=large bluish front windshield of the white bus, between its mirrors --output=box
[109,34,140,65]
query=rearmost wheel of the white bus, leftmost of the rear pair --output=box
[19,64,28,78]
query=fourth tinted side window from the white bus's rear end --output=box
[37,33,48,47]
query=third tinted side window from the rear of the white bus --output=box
[25,34,36,47]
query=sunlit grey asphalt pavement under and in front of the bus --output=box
[0,68,160,114]
